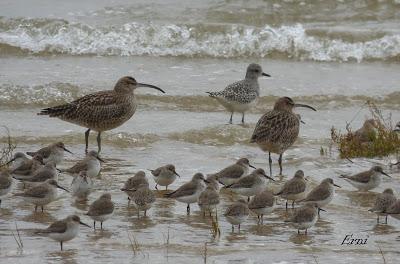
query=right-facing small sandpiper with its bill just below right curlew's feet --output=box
[224,169,275,201]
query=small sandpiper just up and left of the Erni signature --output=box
[285,203,325,235]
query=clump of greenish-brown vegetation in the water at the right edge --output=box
[331,102,400,158]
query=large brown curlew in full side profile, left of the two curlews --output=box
[38,76,165,153]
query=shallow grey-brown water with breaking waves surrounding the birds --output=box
[0,0,400,263]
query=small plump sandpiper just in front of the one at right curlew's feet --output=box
[249,190,275,224]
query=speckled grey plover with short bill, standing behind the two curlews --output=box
[207,63,271,124]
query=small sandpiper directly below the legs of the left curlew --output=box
[61,150,104,178]
